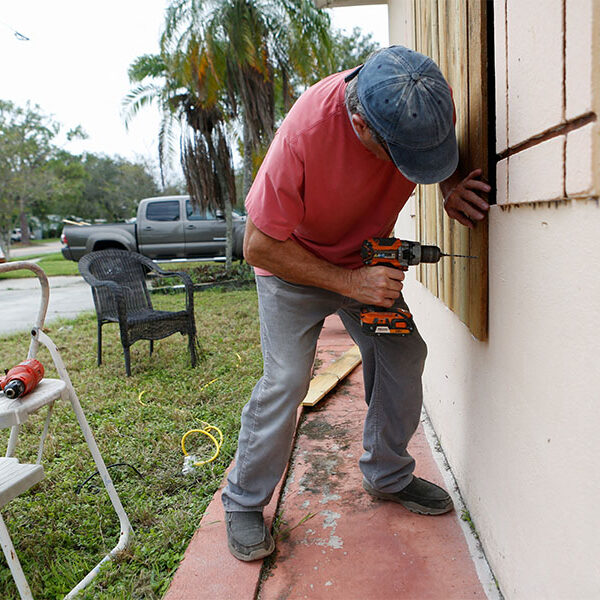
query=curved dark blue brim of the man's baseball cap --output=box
[388,127,458,184]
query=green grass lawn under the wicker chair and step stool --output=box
[0,288,262,600]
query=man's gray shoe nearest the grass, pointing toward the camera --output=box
[225,511,275,561]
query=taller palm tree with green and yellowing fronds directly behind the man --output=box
[161,0,333,195]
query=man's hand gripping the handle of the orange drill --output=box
[348,267,404,308]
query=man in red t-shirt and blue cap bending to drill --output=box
[223,46,490,561]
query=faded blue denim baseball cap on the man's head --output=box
[346,46,458,183]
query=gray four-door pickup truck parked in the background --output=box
[61,196,246,261]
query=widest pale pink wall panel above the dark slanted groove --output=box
[507,0,564,146]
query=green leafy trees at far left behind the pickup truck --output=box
[0,100,159,256]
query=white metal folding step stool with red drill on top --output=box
[0,262,131,600]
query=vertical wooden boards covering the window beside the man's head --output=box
[414,0,493,340]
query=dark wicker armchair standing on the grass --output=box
[79,248,197,376]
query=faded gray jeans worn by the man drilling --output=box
[223,277,427,511]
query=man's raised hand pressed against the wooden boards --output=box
[440,169,492,229]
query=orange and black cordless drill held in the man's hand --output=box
[360,238,475,335]
